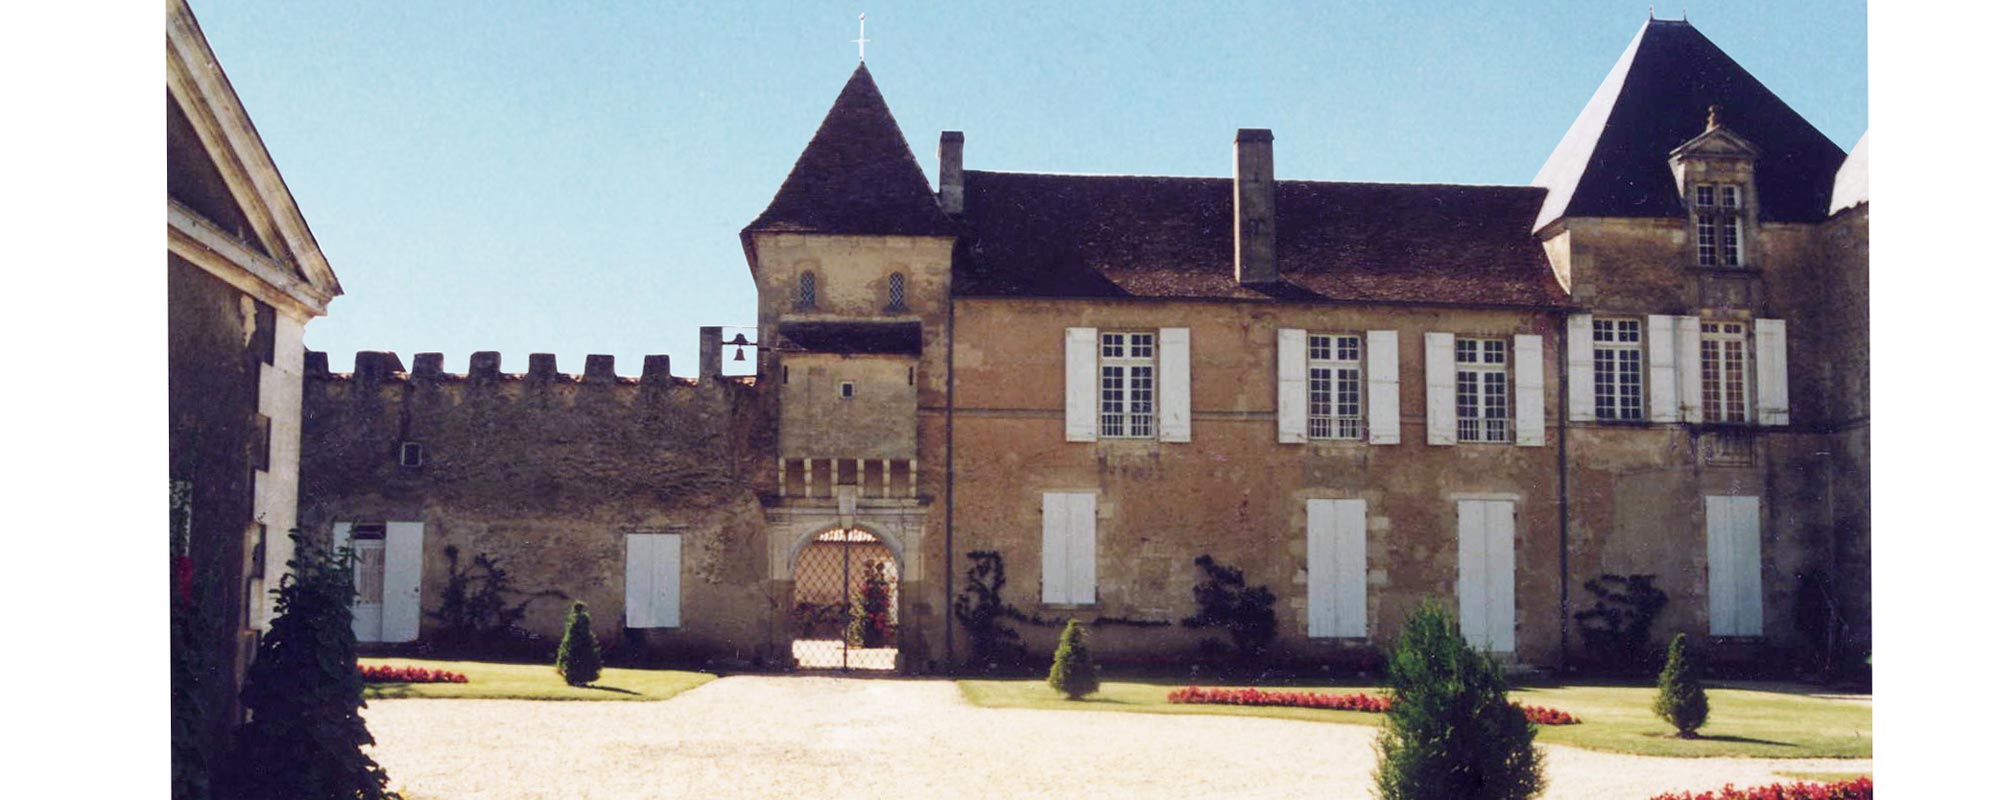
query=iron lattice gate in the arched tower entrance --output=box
[792,530,898,670]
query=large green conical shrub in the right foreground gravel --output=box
[1374,602,1542,800]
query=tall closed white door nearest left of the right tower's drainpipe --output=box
[1458,500,1514,652]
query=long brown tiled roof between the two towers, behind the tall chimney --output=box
[952,170,1568,306]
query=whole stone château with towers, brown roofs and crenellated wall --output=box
[300,20,1870,670]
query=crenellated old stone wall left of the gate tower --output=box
[300,352,782,660]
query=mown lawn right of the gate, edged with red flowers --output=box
[958,680,1874,758]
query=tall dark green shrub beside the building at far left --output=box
[220,530,396,800]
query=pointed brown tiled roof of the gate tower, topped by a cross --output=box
[744,64,952,236]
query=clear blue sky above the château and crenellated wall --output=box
[192,0,1868,376]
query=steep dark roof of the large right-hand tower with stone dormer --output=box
[1534,20,1846,228]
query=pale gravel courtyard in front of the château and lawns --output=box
[364,676,1874,800]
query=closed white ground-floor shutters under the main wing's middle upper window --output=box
[1306,500,1368,638]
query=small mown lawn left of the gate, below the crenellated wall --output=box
[360,658,716,700]
